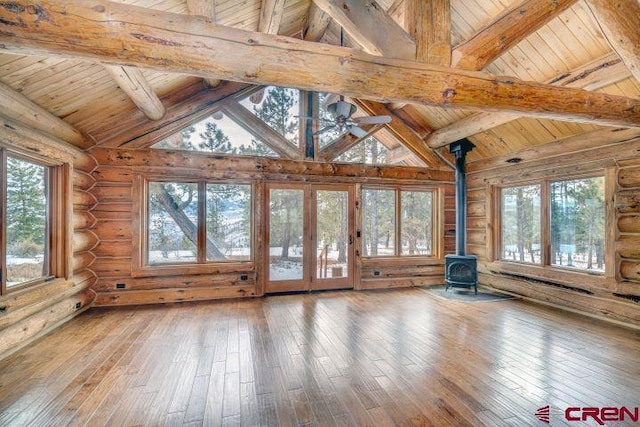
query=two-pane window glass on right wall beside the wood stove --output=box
[500,177,605,272]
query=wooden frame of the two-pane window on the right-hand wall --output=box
[486,172,616,281]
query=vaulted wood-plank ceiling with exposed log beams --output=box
[0,0,640,167]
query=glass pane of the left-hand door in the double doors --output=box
[268,188,304,282]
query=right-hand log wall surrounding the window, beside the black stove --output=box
[467,140,640,326]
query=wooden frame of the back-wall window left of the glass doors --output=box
[131,175,257,277]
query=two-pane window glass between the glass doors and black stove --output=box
[362,188,435,257]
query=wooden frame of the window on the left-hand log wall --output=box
[0,147,72,295]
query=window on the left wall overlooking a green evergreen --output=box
[0,149,64,293]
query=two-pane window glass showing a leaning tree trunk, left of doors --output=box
[146,181,252,265]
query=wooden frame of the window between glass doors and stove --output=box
[358,184,444,260]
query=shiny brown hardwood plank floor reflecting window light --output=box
[0,288,640,427]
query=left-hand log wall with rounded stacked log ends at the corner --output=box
[0,121,97,358]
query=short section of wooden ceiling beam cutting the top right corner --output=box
[586,0,640,82]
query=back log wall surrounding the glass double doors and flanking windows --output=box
[91,148,455,305]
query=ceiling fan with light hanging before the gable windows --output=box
[300,96,391,138]
